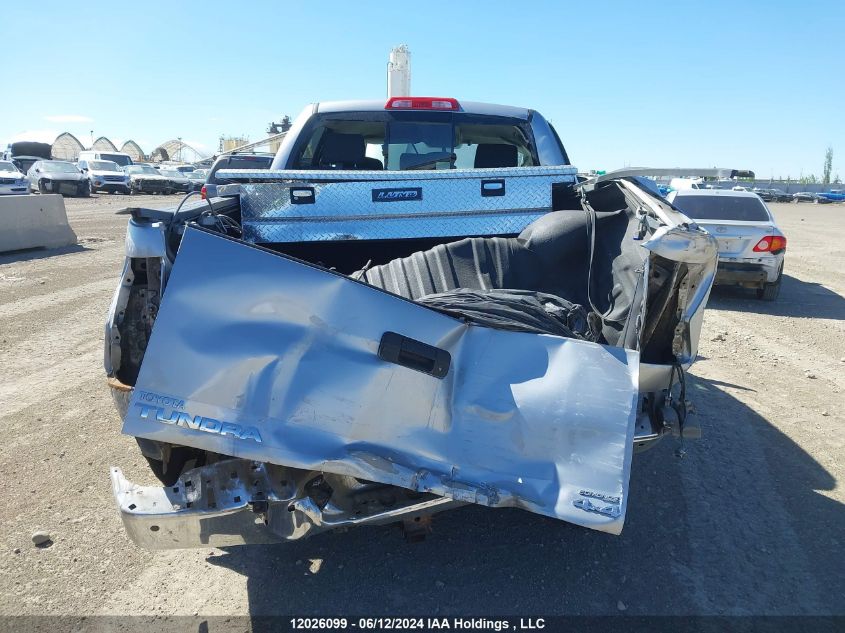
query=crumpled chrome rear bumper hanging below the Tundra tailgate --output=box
[111,459,465,550]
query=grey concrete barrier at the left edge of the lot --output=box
[0,194,76,253]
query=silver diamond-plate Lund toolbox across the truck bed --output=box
[218,166,576,244]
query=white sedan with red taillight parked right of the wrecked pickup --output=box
[667,189,786,301]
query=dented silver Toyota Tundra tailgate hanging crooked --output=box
[123,228,639,534]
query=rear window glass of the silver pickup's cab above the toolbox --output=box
[290,112,539,171]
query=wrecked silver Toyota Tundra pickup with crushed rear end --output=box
[105,98,725,549]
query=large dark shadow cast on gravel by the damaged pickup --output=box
[207,377,845,624]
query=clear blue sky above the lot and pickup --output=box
[0,0,845,179]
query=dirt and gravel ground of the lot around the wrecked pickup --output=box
[0,195,845,615]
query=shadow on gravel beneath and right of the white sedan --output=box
[707,275,845,321]
